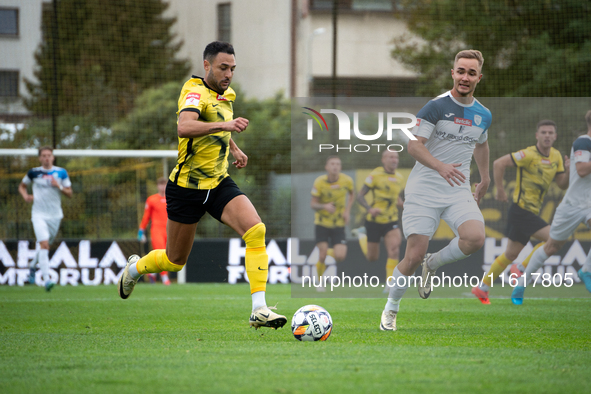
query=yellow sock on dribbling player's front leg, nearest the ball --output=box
[242,223,269,294]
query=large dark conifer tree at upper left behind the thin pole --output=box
[26,0,189,126]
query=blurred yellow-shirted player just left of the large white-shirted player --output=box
[355,150,404,284]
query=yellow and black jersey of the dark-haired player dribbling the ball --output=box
[170,75,236,189]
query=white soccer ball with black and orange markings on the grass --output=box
[291,305,332,341]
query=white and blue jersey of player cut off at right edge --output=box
[562,134,591,209]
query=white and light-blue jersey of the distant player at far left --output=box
[22,166,72,219]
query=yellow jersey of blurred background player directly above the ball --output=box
[312,174,353,228]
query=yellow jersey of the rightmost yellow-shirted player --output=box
[511,145,564,215]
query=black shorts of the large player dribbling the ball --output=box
[166,176,244,224]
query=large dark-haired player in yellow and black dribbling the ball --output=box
[118,41,287,329]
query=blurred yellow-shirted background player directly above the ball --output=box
[310,156,355,291]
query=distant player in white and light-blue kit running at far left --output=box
[18,146,72,291]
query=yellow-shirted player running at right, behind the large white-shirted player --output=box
[472,120,570,304]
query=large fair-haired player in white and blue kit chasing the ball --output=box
[380,49,492,331]
